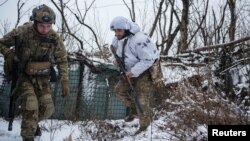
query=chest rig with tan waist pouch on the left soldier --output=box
[16,26,57,75]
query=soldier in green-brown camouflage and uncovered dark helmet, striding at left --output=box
[0,4,69,141]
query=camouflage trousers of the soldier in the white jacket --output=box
[115,71,153,127]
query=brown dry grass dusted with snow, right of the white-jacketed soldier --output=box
[152,76,249,140]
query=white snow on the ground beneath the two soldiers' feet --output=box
[0,118,171,141]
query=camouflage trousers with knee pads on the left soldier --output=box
[16,77,54,138]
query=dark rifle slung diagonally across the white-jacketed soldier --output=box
[112,51,143,114]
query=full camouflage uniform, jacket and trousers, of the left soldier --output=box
[0,23,68,138]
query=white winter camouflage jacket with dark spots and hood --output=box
[112,22,160,77]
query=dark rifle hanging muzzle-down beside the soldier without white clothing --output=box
[8,56,19,131]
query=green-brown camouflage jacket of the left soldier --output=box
[0,23,68,80]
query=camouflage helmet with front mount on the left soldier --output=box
[30,4,56,24]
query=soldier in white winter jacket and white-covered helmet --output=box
[110,17,159,133]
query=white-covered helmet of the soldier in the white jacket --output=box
[110,16,131,30]
